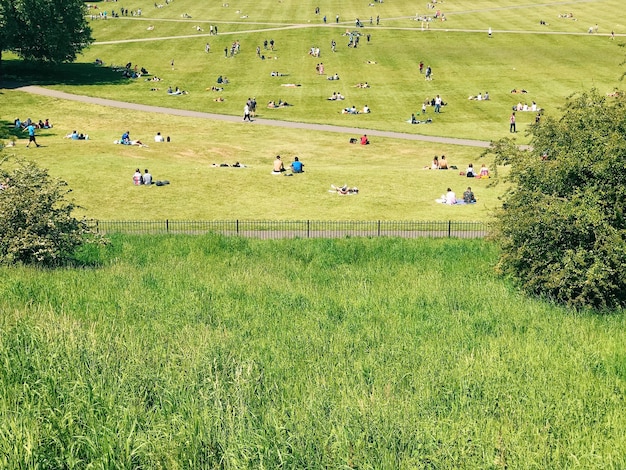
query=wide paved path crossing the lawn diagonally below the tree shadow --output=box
[6,85,490,148]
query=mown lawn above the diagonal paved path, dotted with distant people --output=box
[2,0,624,143]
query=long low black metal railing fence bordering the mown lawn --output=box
[91,219,488,239]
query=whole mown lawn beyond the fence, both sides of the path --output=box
[0,0,626,220]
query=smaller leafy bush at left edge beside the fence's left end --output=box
[0,159,104,266]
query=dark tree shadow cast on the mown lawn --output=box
[0,59,131,89]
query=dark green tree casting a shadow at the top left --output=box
[0,0,93,79]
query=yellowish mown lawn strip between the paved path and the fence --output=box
[2,91,504,220]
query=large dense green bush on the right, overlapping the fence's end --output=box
[487,90,626,309]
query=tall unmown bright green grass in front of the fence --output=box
[0,236,626,469]
